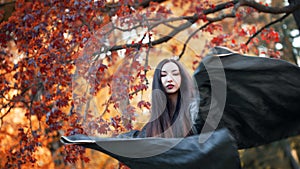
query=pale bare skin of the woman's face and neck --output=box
[161,62,181,116]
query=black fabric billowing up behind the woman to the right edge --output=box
[194,47,300,149]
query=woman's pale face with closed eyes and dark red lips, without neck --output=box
[160,62,181,94]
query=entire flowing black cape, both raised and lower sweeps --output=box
[61,47,300,169]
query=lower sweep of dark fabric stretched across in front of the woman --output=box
[61,129,240,169]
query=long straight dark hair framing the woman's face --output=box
[146,59,198,137]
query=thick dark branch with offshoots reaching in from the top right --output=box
[97,0,300,58]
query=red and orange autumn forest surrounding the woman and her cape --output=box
[0,0,300,169]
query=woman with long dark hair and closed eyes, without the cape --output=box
[145,59,199,137]
